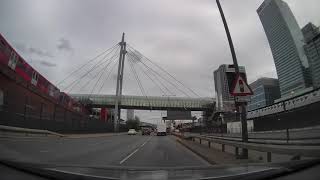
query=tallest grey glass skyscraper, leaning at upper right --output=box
[257,0,310,97]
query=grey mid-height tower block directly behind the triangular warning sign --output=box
[213,64,246,110]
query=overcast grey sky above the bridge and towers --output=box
[0,0,320,122]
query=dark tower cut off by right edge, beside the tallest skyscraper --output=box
[302,23,320,88]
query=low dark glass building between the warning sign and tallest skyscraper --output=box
[248,77,280,111]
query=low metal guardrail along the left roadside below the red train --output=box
[0,125,65,137]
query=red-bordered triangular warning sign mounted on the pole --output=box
[231,74,253,96]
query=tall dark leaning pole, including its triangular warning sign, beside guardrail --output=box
[216,0,252,159]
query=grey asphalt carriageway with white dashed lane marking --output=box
[0,135,209,167]
